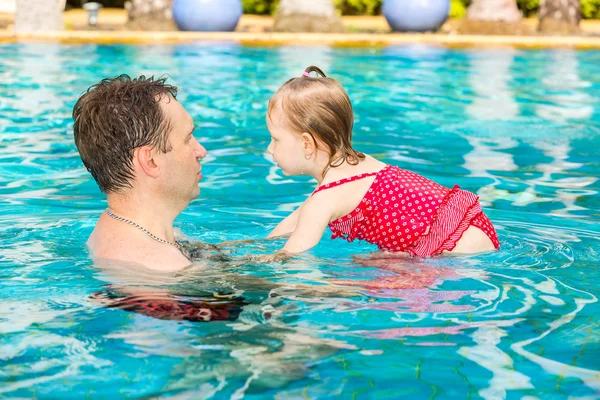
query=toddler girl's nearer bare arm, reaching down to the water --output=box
[283,197,333,254]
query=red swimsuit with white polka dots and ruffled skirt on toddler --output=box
[313,165,500,257]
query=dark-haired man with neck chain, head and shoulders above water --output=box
[73,75,206,272]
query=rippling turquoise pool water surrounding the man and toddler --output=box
[0,44,600,399]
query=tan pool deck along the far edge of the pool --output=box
[0,9,600,49]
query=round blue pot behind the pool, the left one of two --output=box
[173,0,242,32]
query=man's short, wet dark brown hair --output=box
[73,75,177,193]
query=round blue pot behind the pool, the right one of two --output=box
[381,0,450,32]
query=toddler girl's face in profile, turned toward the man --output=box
[267,107,314,176]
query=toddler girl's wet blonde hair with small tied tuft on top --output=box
[267,66,365,176]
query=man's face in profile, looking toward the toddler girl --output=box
[158,96,206,205]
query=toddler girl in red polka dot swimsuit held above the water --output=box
[267,66,500,257]
